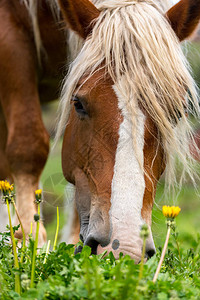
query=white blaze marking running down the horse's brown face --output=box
[110,86,145,247]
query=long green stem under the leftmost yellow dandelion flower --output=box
[6,199,21,295]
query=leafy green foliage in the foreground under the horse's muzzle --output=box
[0,229,200,300]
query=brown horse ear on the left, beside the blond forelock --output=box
[58,0,100,39]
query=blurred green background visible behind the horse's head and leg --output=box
[41,43,200,248]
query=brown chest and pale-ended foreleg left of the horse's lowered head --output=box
[0,0,67,244]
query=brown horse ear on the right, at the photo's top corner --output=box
[166,0,200,41]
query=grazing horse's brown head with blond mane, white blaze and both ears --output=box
[56,0,200,262]
